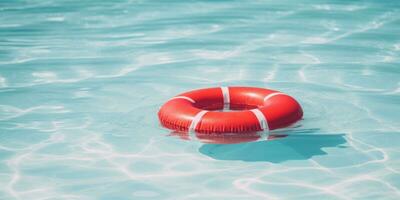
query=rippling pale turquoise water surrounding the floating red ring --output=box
[0,0,400,199]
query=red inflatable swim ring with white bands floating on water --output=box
[158,87,303,136]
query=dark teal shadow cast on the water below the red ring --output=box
[199,134,346,163]
